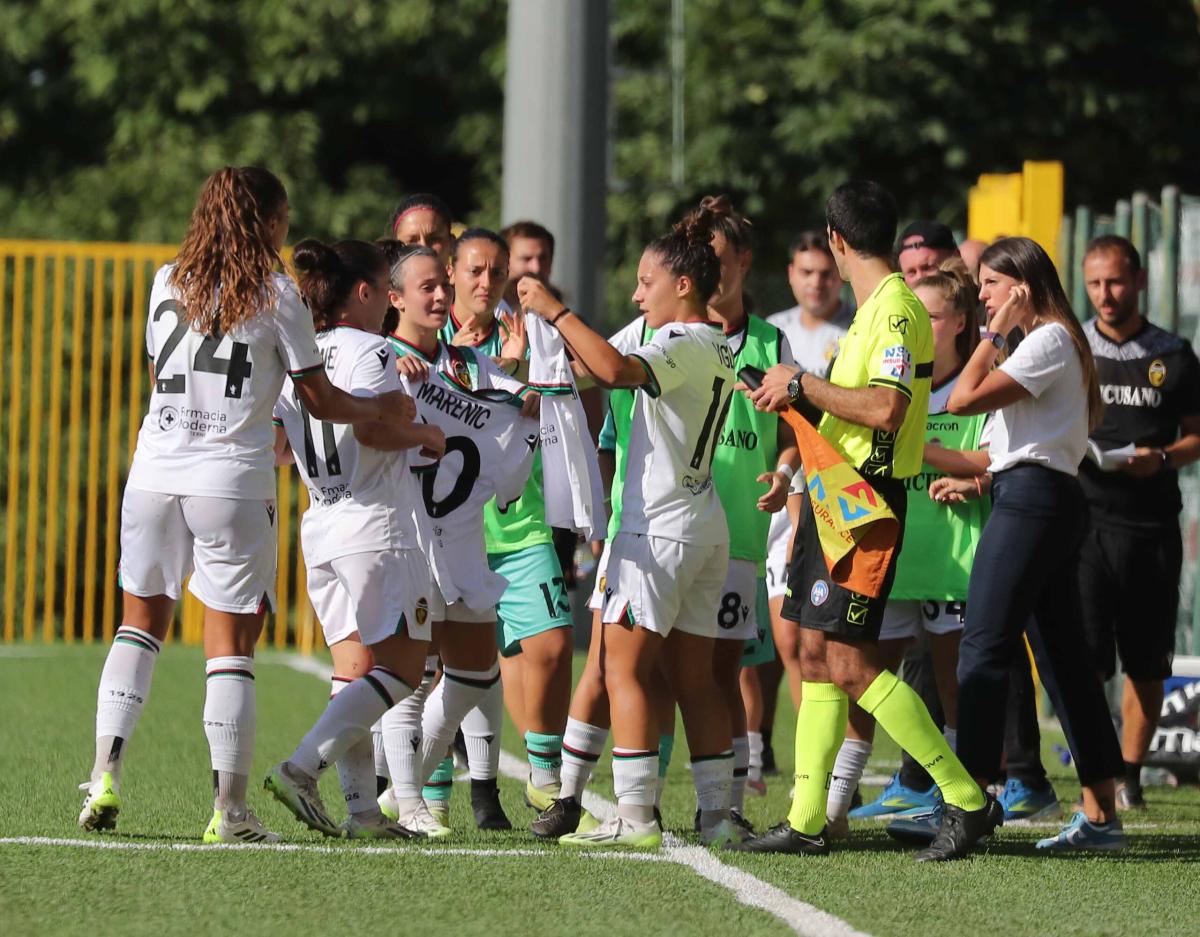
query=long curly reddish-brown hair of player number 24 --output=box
[168,166,288,335]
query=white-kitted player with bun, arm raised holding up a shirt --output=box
[517,212,739,847]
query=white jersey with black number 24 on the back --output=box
[128,264,322,499]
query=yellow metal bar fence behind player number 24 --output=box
[0,240,320,651]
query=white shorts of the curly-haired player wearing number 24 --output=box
[118,486,278,614]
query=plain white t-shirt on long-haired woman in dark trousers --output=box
[988,323,1087,475]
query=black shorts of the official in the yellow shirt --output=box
[782,476,908,641]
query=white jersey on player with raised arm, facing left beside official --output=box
[620,323,736,545]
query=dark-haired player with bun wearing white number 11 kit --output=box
[265,240,445,837]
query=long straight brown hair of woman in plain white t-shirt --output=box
[979,238,1104,430]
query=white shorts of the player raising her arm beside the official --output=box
[600,531,730,638]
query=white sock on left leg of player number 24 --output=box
[91,625,162,781]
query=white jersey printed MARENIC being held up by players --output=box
[388,336,540,612]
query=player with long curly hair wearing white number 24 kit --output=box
[79,167,415,842]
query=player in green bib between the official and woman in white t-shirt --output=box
[826,259,988,836]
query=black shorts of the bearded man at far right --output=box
[1079,525,1183,680]
